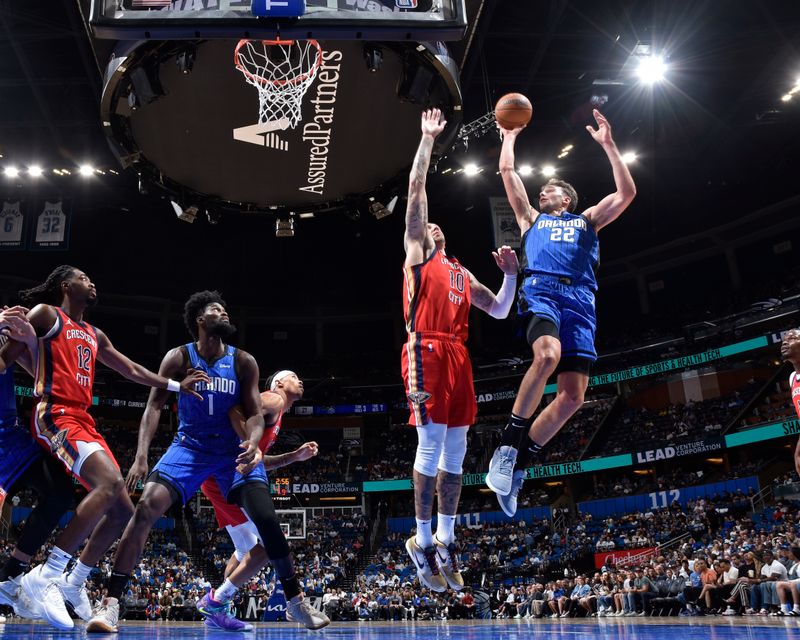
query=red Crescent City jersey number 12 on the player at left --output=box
[34,307,97,409]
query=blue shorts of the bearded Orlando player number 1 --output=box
[148,436,267,504]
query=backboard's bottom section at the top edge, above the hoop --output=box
[89,0,467,41]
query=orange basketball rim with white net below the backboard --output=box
[233,40,322,129]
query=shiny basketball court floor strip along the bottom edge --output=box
[0,617,800,640]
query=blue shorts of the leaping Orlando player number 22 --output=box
[519,275,597,361]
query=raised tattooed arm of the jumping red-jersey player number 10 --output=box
[404,109,447,266]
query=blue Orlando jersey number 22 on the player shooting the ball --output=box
[520,212,600,291]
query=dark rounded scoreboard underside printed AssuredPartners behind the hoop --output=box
[101,39,462,213]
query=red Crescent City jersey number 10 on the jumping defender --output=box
[403,249,470,341]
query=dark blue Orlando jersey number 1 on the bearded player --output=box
[177,343,239,453]
